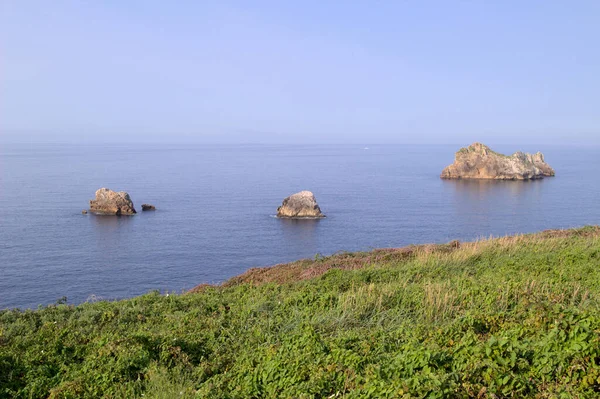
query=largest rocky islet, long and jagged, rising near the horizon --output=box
[441,143,554,180]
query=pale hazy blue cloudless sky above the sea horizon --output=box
[0,0,600,144]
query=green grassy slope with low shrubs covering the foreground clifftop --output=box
[0,227,600,398]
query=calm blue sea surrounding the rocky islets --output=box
[0,143,600,308]
